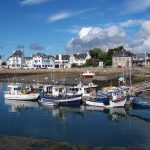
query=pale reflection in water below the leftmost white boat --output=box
[4,99,39,112]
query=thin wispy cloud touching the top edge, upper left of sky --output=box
[20,0,48,6]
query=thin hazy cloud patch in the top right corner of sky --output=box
[125,0,150,13]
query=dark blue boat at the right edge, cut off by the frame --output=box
[132,98,150,109]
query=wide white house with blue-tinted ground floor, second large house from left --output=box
[32,53,55,69]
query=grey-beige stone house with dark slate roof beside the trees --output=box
[112,50,136,68]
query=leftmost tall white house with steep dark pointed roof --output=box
[7,50,24,69]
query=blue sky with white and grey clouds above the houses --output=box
[0,0,150,59]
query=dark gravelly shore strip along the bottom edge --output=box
[0,135,144,150]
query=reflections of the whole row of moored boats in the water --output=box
[4,99,150,122]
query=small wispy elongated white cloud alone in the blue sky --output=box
[48,12,72,22]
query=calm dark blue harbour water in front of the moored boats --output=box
[0,83,150,149]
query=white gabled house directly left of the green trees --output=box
[69,52,91,66]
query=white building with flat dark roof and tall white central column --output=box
[55,55,70,68]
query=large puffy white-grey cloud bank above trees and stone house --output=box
[66,20,150,53]
